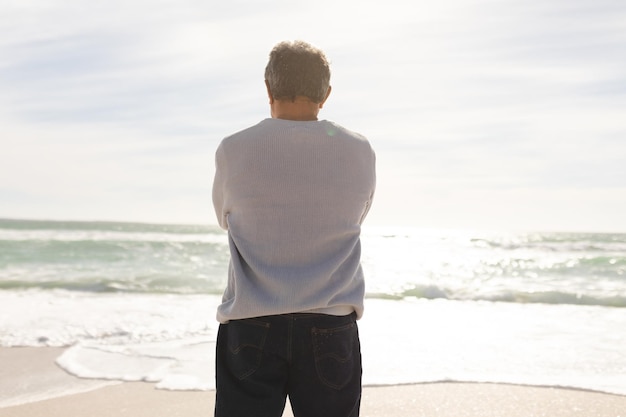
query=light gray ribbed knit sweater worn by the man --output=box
[213,119,376,323]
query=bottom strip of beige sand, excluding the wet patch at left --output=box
[0,382,626,417]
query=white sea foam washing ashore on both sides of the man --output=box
[0,292,626,401]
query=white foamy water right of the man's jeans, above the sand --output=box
[360,300,626,394]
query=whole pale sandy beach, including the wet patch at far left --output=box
[0,348,626,417]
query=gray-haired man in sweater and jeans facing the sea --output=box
[213,41,375,417]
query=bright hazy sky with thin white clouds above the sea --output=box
[0,0,626,232]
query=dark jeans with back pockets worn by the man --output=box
[215,313,361,417]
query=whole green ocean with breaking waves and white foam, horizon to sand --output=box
[0,219,626,395]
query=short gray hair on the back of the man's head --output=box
[265,41,330,103]
